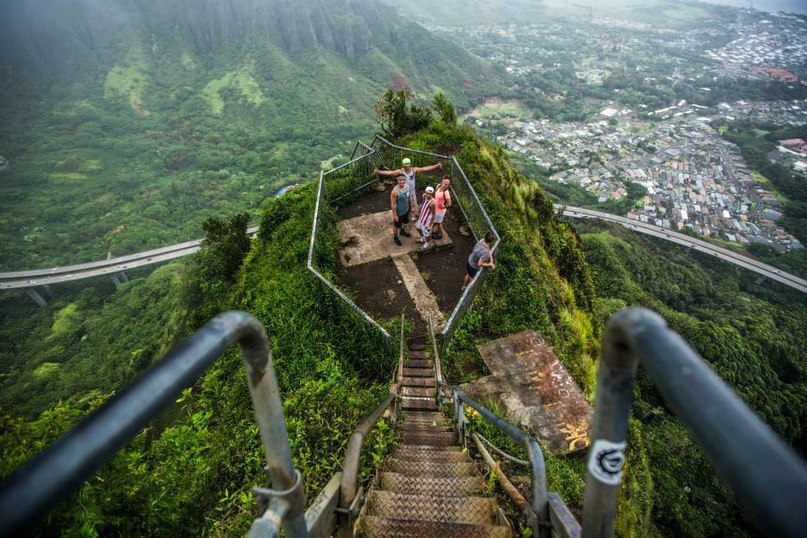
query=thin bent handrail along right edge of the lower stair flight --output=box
[429,317,551,538]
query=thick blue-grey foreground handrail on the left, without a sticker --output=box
[0,311,308,537]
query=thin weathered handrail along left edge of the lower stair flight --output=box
[337,314,405,537]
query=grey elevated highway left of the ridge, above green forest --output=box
[0,226,258,290]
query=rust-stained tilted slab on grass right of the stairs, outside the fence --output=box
[462,331,592,452]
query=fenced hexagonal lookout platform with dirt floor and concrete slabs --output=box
[309,137,495,337]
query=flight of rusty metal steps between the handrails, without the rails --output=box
[357,343,512,538]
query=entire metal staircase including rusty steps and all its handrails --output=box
[0,309,807,538]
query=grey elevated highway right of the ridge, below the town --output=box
[555,204,807,293]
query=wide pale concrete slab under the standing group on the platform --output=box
[336,211,452,267]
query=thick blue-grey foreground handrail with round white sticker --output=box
[583,308,807,538]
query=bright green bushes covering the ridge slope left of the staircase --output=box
[0,179,393,536]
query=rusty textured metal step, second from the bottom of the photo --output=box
[367,490,498,525]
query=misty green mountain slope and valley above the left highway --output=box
[0,0,498,269]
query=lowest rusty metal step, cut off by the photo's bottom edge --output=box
[358,516,513,538]
